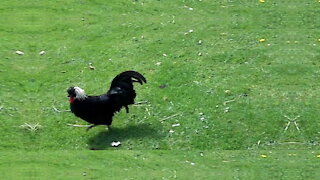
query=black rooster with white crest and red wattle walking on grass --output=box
[67,71,147,131]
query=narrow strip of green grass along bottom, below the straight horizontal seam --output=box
[0,150,320,179]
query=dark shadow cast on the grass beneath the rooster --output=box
[88,124,162,150]
